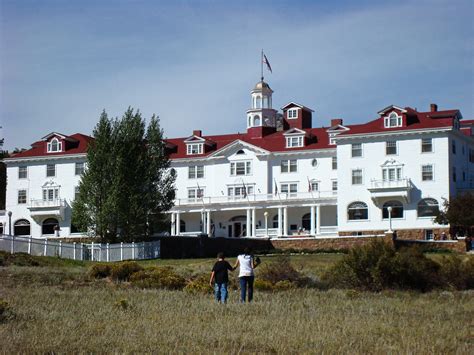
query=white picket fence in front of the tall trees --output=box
[0,235,160,261]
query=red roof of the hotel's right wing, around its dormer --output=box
[340,107,459,136]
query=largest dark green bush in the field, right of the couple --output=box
[323,240,440,292]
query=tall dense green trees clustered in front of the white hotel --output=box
[72,108,175,241]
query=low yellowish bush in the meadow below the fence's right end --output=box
[130,267,186,290]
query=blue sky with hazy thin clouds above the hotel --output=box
[0,0,474,150]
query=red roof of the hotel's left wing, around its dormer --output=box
[10,133,94,159]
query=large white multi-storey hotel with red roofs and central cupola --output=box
[1,80,474,239]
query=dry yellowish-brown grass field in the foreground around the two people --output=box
[0,254,474,354]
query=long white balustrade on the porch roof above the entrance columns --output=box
[175,191,337,206]
